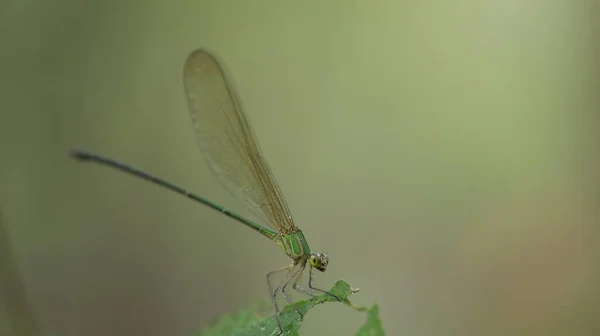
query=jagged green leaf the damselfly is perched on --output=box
[198,280,385,336]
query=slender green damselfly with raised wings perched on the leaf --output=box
[69,48,341,335]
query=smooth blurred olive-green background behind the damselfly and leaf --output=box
[0,0,600,336]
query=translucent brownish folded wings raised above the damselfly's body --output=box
[183,49,295,232]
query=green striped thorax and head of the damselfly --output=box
[275,230,329,272]
